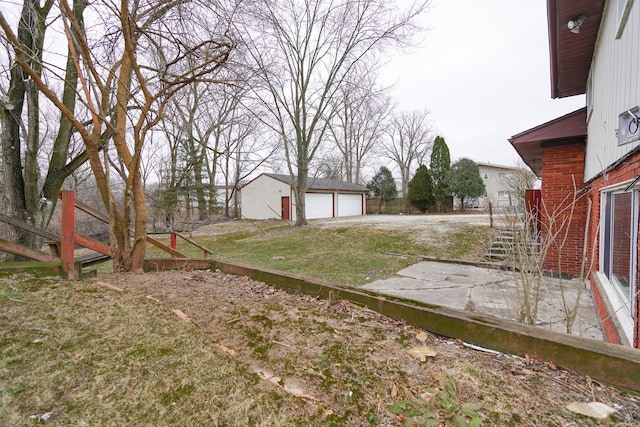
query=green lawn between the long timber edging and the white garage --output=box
[149,223,492,285]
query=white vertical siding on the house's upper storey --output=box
[584,1,640,181]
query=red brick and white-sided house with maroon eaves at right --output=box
[510,0,640,348]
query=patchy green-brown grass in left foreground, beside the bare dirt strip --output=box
[0,276,304,426]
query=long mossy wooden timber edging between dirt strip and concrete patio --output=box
[209,261,640,392]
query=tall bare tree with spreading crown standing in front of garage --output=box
[238,0,426,225]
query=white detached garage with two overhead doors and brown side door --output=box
[240,173,367,221]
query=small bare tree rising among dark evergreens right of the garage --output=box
[382,110,434,213]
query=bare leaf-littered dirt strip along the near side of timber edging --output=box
[99,270,640,426]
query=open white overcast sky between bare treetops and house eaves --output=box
[383,0,585,166]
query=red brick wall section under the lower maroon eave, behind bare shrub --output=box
[540,142,589,276]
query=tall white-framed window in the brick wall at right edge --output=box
[602,190,640,337]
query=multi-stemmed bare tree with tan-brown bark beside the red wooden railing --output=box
[0,0,234,271]
